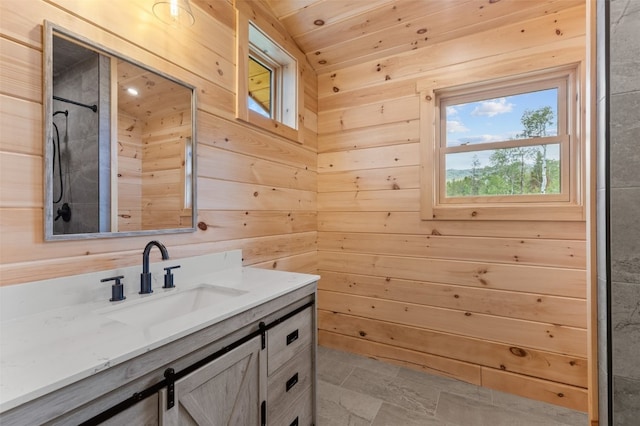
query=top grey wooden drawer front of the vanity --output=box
[267,307,313,375]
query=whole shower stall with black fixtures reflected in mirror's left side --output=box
[51,37,111,235]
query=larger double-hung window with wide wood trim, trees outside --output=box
[423,69,582,220]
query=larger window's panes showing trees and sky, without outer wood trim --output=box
[439,81,568,202]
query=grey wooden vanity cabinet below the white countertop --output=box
[0,290,317,426]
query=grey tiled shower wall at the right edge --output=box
[598,0,640,426]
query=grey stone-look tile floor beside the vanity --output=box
[318,346,587,426]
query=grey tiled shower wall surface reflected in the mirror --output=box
[52,55,111,234]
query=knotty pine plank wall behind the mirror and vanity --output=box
[0,0,317,284]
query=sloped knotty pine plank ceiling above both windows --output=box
[266,0,585,73]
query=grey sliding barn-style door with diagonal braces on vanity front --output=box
[159,336,264,426]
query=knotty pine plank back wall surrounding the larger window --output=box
[318,5,587,411]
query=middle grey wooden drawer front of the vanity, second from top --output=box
[267,348,312,418]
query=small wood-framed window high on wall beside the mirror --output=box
[236,2,304,142]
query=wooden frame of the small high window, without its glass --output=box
[236,1,305,143]
